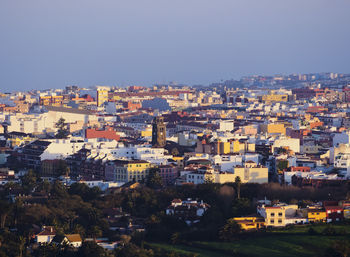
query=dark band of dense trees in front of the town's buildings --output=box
[0,172,349,257]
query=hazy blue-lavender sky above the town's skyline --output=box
[0,0,350,92]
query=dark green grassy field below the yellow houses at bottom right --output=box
[150,229,349,257]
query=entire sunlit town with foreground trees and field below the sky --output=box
[0,72,350,254]
